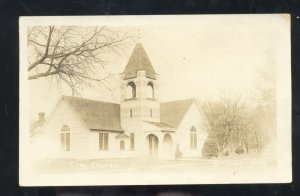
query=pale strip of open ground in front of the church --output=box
[33,153,276,174]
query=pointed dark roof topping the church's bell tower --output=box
[123,43,156,79]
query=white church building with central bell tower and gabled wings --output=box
[31,43,208,159]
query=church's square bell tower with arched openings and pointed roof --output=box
[120,43,160,128]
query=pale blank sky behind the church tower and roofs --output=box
[26,15,290,121]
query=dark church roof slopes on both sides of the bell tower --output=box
[55,96,205,132]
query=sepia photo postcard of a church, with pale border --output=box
[19,14,292,186]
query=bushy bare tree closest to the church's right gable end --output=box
[203,97,254,155]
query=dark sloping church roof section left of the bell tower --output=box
[63,96,124,132]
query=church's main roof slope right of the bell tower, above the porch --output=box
[160,99,198,128]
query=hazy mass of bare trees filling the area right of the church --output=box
[203,67,277,158]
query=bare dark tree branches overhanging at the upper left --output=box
[28,26,134,93]
